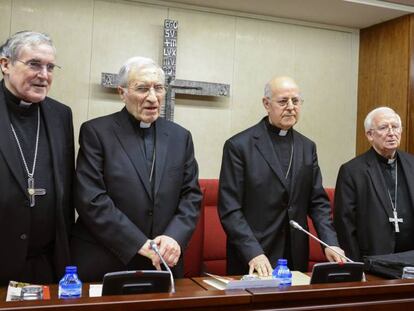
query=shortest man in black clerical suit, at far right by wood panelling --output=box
[334,107,414,260]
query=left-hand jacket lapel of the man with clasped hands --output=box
[114,107,152,199]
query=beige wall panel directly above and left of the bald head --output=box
[231,18,296,134]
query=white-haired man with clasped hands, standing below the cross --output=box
[72,57,202,281]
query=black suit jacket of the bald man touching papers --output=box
[219,119,338,274]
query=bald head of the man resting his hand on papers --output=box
[262,77,302,130]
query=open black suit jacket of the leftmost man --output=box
[0,87,74,284]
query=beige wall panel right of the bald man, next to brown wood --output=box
[295,27,358,187]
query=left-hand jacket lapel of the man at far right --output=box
[367,148,393,217]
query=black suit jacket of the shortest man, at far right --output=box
[334,148,414,260]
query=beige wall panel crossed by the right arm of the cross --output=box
[169,10,235,178]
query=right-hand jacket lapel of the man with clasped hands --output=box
[154,118,169,195]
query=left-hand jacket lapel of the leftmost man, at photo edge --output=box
[0,86,27,195]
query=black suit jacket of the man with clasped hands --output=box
[72,108,202,281]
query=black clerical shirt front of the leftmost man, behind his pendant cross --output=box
[1,82,56,266]
